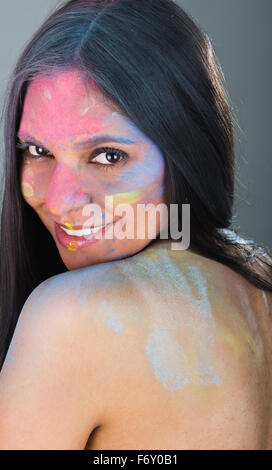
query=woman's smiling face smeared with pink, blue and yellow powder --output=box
[18,69,165,270]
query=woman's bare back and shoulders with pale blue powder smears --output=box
[0,241,272,450]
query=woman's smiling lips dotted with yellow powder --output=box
[55,221,116,251]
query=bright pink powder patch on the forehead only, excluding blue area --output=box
[20,70,103,147]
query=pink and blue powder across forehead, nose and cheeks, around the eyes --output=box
[18,69,164,225]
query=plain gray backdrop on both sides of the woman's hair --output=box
[0,0,272,249]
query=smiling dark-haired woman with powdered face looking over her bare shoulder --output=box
[0,0,272,449]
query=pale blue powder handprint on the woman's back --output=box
[142,260,220,391]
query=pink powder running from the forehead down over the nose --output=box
[19,70,115,213]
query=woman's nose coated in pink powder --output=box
[46,163,91,215]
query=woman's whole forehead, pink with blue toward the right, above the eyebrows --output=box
[19,70,140,144]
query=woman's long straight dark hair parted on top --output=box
[0,0,272,365]
